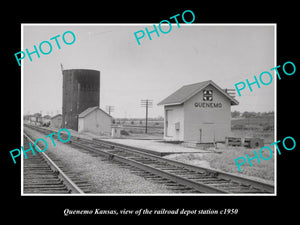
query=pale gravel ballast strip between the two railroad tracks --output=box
[24,127,172,194]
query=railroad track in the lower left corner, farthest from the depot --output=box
[23,134,85,194]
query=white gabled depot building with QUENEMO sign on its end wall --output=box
[158,80,239,143]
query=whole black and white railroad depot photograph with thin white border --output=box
[20,23,276,195]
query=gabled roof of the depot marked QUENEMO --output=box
[158,80,239,105]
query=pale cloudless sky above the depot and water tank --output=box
[22,22,276,118]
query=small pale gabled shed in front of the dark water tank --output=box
[78,106,112,135]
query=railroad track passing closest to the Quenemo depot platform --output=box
[24,124,274,194]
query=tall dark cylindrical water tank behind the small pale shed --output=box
[62,69,100,131]
